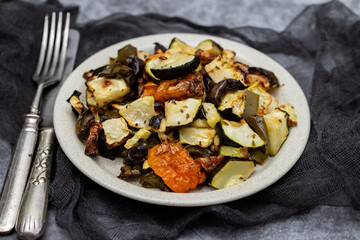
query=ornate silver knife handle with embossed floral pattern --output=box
[15,128,55,239]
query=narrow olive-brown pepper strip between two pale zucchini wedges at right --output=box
[245,115,270,155]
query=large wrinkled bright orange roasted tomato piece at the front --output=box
[147,141,206,193]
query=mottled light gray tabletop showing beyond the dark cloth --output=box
[4,0,360,240]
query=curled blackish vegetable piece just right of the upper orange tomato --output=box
[206,79,246,106]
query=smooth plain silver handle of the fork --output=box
[0,113,40,233]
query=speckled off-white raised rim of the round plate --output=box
[54,33,311,207]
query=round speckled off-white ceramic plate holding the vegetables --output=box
[54,33,310,207]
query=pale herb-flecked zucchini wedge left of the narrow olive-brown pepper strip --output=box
[216,119,265,148]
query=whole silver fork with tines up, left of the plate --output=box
[0,12,70,233]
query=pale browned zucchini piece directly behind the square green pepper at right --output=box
[248,82,278,115]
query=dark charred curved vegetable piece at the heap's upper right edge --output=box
[245,67,279,90]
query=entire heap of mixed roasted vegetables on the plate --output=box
[67,38,297,193]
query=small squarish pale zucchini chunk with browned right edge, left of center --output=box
[102,118,132,148]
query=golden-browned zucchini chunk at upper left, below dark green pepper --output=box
[86,77,130,107]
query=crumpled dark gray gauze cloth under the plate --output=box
[0,1,360,239]
